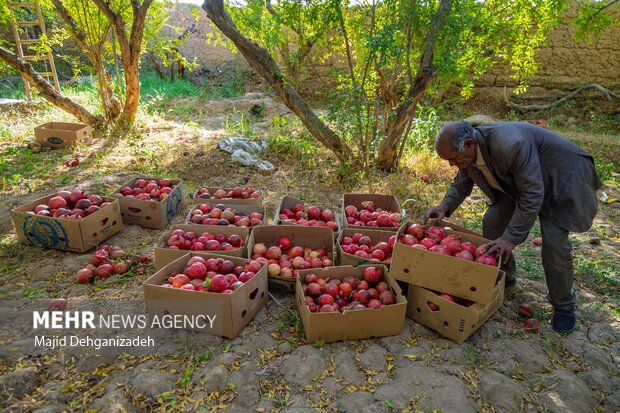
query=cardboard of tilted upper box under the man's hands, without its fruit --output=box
[390,222,500,304]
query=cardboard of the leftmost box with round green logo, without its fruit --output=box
[11,194,123,252]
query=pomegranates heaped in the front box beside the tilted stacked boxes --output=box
[302,267,396,313]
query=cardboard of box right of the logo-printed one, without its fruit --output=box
[112,177,183,229]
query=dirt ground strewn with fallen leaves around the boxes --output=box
[0,94,620,413]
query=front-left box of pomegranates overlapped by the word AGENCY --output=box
[143,252,268,338]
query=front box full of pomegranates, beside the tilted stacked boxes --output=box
[295,265,407,343]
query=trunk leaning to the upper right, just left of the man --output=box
[377,0,453,171]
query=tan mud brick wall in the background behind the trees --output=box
[169,5,620,91]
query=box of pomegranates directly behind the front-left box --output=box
[154,224,249,270]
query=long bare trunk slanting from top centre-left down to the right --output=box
[202,0,352,162]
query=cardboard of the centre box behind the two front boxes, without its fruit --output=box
[248,225,336,292]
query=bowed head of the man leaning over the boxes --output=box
[435,121,476,169]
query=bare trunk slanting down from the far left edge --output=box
[0,47,102,126]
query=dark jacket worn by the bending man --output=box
[442,122,601,244]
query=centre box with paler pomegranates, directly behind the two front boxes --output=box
[248,225,335,291]
